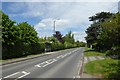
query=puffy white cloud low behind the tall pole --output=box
[34,18,69,37]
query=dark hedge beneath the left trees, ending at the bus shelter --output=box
[2,43,45,59]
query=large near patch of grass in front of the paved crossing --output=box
[84,58,120,79]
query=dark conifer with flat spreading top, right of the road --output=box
[86,12,113,50]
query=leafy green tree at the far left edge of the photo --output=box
[1,11,17,45]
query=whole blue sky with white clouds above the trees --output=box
[2,0,118,41]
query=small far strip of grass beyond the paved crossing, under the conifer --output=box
[84,48,105,57]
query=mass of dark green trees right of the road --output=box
[86,12,120,57]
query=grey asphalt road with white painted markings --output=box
[1,48,84,80]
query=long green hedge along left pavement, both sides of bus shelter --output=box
[2,42,84,59]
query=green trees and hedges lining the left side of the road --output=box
[0,11,85,59]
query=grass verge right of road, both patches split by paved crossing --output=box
[84,48,120,80]
